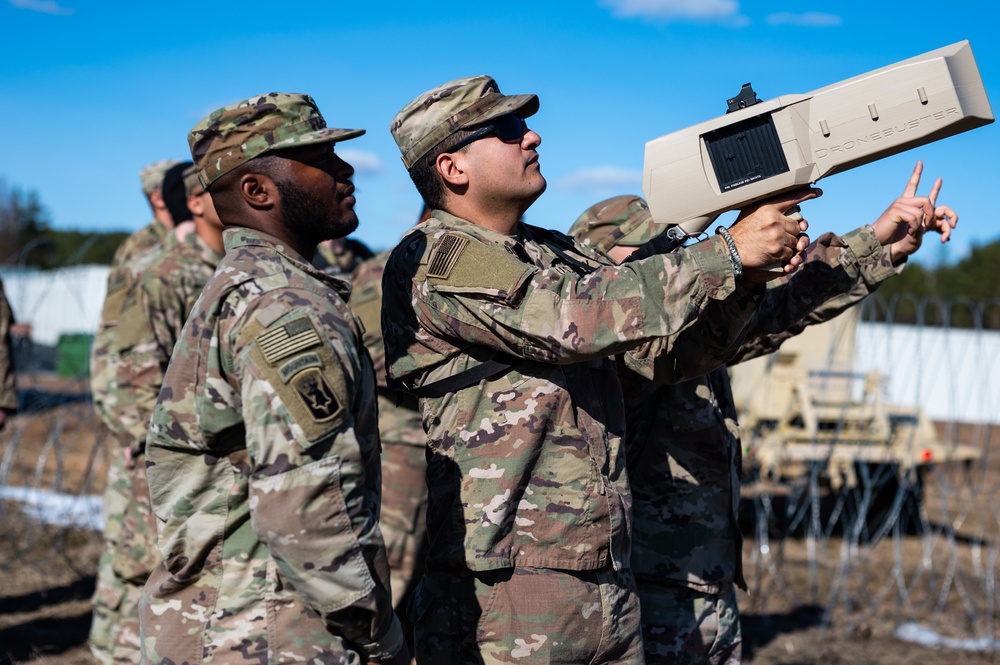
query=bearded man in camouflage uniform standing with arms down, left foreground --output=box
[141,93,409,665]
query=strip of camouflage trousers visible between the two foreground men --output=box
[379,441,427,611]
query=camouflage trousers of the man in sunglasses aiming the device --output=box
[410,568,643,665]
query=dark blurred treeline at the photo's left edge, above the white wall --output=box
[0,180,128,269]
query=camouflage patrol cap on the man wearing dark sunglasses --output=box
[389,76,538,170]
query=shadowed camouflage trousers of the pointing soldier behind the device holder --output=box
[638,580,743,665]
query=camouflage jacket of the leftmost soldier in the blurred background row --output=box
[90,219,175,435]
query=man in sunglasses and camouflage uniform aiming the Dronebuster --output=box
[382,76,813,664]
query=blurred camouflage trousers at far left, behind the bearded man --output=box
[89,454,159,665]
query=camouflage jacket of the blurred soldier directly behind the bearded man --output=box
[115,233,222,458]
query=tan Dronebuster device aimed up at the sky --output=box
[642,41,993,244]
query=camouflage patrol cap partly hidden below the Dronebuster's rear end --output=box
[569,194,668,252]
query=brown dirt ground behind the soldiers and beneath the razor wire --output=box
[0,382,1000,665]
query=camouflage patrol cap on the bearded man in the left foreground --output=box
[188,92,365,189]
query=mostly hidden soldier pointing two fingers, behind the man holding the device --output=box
[570,164,957,665]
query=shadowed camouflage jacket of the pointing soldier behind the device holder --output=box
[622,226,897,595]
